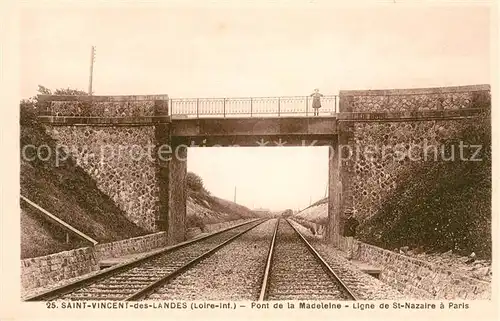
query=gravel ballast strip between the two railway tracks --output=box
[146,219,276,300]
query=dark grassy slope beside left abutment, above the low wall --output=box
[20,87,147,258]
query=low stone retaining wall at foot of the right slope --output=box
[339,238,491,300]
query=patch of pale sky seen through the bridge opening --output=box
[188,146,328,211]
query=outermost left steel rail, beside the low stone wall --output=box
[23,219,264,302]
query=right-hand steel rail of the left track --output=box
[122,220,266,301]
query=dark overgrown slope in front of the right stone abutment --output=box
[358,111,491,258]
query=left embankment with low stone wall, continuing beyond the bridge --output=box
[20,102,262,291]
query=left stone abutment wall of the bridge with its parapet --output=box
[38,95,169,232]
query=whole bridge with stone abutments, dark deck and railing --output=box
[38,85,491,244]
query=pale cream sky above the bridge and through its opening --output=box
[20,3,490,210]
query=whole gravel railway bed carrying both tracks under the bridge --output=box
[24,218,404,300]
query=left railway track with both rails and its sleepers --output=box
[25,220,265,301]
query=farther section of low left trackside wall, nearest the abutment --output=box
[94,232,167,261]
